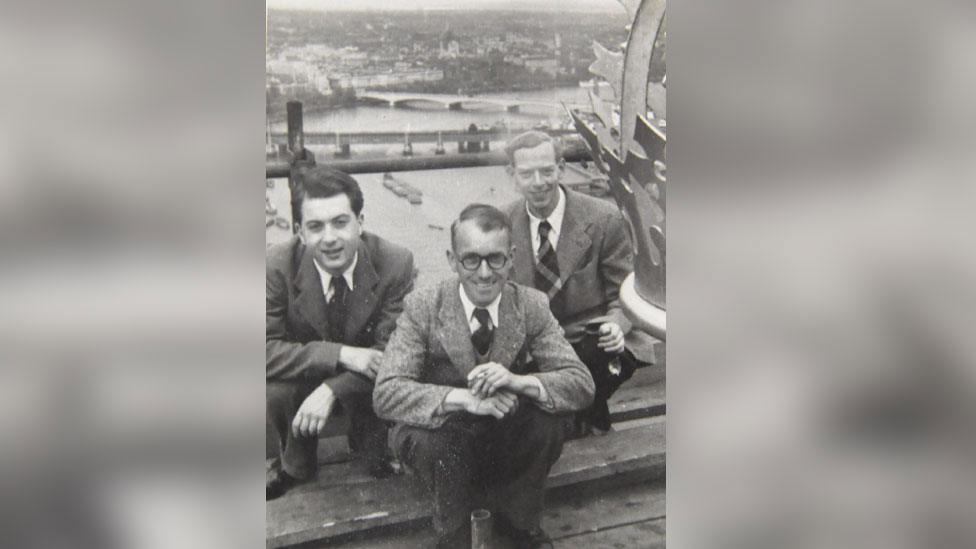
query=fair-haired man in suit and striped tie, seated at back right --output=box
[505,131,654,434]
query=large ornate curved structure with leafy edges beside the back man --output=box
[572,0,667,309]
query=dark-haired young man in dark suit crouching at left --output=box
[265,167,414,499]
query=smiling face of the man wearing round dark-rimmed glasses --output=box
[447,220,513,307]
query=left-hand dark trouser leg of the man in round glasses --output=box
[393,421,477,536]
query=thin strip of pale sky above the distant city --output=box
[267,0,623,12]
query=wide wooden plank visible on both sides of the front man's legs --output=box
[266,421,665,547]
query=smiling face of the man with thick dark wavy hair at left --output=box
[298,194,363,275]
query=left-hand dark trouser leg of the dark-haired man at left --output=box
[265,381,318,480]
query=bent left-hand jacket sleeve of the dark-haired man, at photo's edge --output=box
[265,256,340,383]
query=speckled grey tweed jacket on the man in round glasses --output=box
[373,278,594,428]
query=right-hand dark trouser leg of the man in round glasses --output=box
[485,400,572,530]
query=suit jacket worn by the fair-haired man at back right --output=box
[505,187,654,363]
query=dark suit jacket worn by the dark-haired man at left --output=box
[265,232,414,400]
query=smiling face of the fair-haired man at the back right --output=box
[510,139,562,219]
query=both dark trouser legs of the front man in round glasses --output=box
[393,399,572,536]
